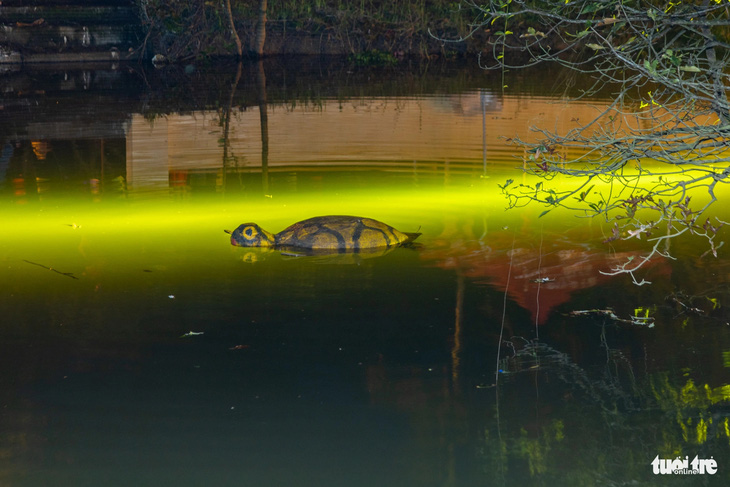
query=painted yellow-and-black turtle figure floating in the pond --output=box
[230,215,421,253]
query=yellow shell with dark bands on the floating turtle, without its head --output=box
[274,215,420,251]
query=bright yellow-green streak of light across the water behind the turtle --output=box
[2,168,728,290]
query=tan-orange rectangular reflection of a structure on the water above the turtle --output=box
[122,92,594,190]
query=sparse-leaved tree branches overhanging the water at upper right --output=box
[440,0,730,285]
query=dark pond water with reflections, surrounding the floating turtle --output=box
[0,60,730,486]
